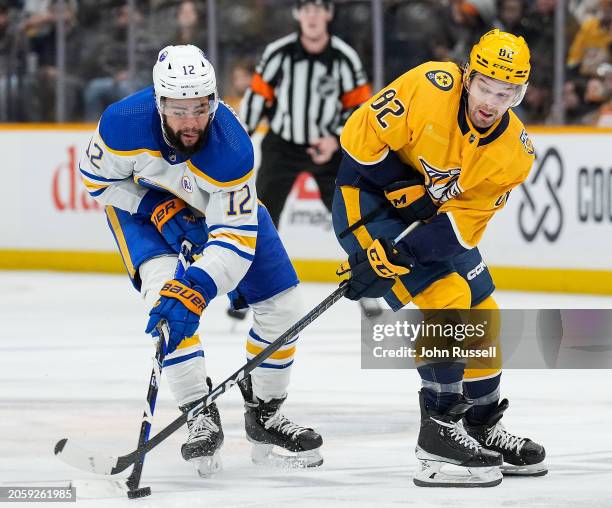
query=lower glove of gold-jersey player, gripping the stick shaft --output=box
[337,238,414,300]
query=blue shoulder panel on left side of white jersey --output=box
[98,87,159,152]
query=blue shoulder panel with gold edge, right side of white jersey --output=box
[187,103,255,188]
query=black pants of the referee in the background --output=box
[256,131,342,229]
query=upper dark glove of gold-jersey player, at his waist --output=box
[385,179,438,225]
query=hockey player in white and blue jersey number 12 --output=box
[80,45,323,476]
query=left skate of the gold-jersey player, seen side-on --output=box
[414,392,502,487]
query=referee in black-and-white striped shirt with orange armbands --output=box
[240,0,371,228]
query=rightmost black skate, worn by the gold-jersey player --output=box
[465,399,548,476]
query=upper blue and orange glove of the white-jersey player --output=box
[151,198,208,253]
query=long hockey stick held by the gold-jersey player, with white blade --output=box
[55,222,420,475]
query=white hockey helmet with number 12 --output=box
[153,44,219,117]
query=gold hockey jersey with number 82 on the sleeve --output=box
[341,62,535,248]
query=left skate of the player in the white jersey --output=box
[180,380,223,478]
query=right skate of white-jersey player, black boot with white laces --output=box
[239,376,323,468]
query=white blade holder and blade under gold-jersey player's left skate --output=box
[413,454,503,488]
